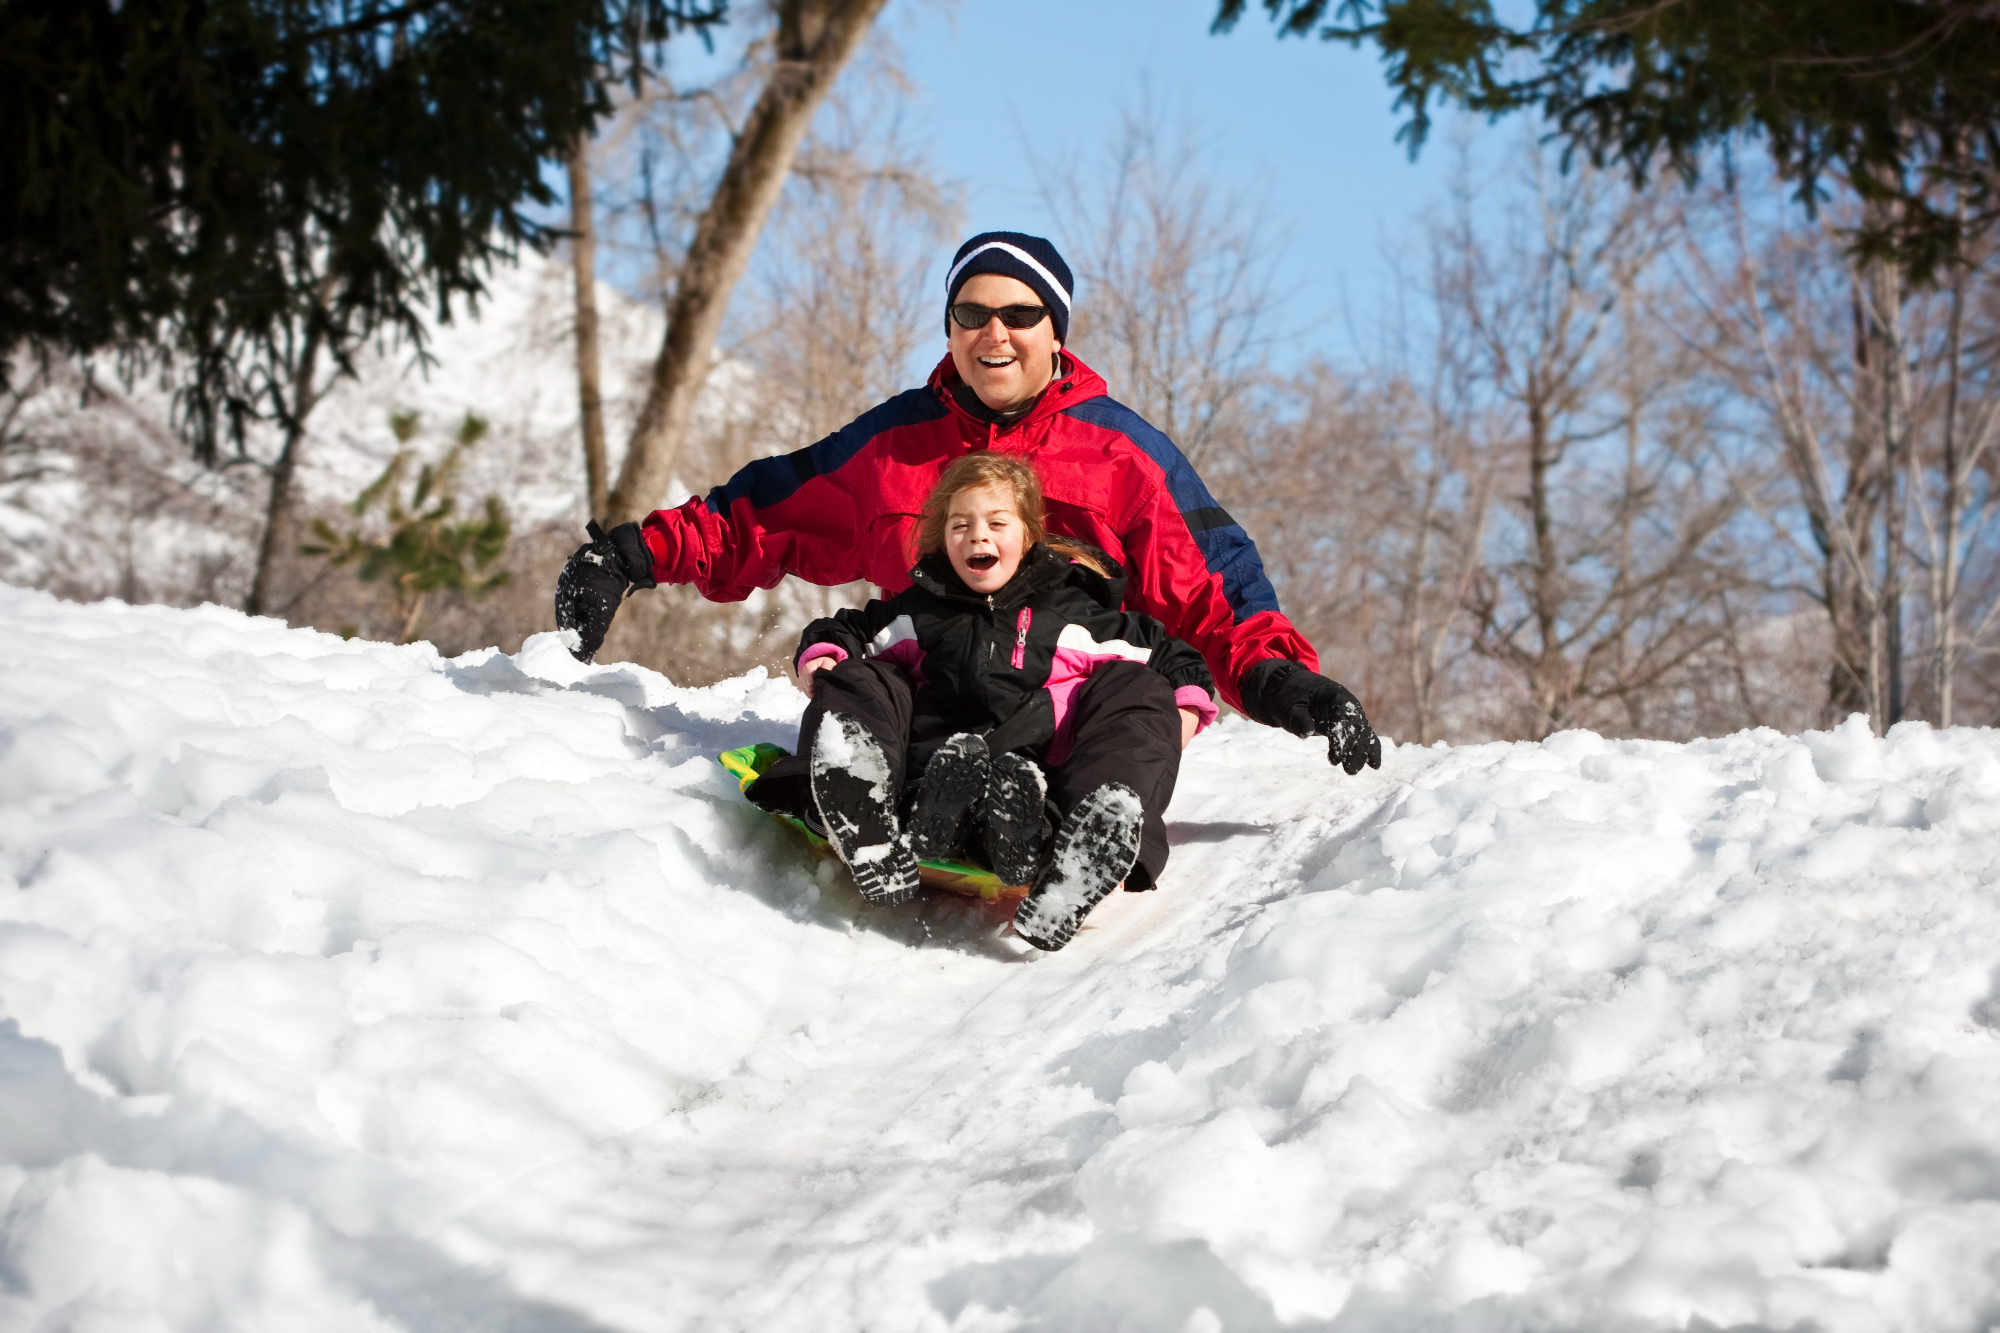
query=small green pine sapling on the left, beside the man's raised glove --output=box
[300,412,512,642]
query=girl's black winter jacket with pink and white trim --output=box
[794,542,1216,753]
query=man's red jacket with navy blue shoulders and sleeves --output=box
[642,352,1320,707]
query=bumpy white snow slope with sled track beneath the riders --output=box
[0,588,2000,1333]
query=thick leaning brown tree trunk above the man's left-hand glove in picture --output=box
[610,0,886,522]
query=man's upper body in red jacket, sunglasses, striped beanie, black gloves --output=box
[556,232,1382,775]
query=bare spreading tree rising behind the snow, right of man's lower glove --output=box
[1438,150,1740,737]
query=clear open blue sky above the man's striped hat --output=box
[882,0,1506,354]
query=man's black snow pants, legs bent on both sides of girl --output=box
[748,658,1180,891]
